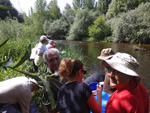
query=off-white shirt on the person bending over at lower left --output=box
[0,77,32,113]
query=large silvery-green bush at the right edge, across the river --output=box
[114,3,150,43]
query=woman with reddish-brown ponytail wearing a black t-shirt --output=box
[57,58,102,113]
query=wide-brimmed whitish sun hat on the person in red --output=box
[102,52,140,77]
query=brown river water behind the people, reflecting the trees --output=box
[55,41,150,107]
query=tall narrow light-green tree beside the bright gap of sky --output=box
[49,0,61,21]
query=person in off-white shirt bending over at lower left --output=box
[0,77,39,113]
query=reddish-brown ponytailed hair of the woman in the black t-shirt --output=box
[59,58,83,80]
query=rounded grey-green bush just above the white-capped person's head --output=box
[44,17,69,40]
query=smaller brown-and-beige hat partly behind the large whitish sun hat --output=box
[97,48,115,60]
